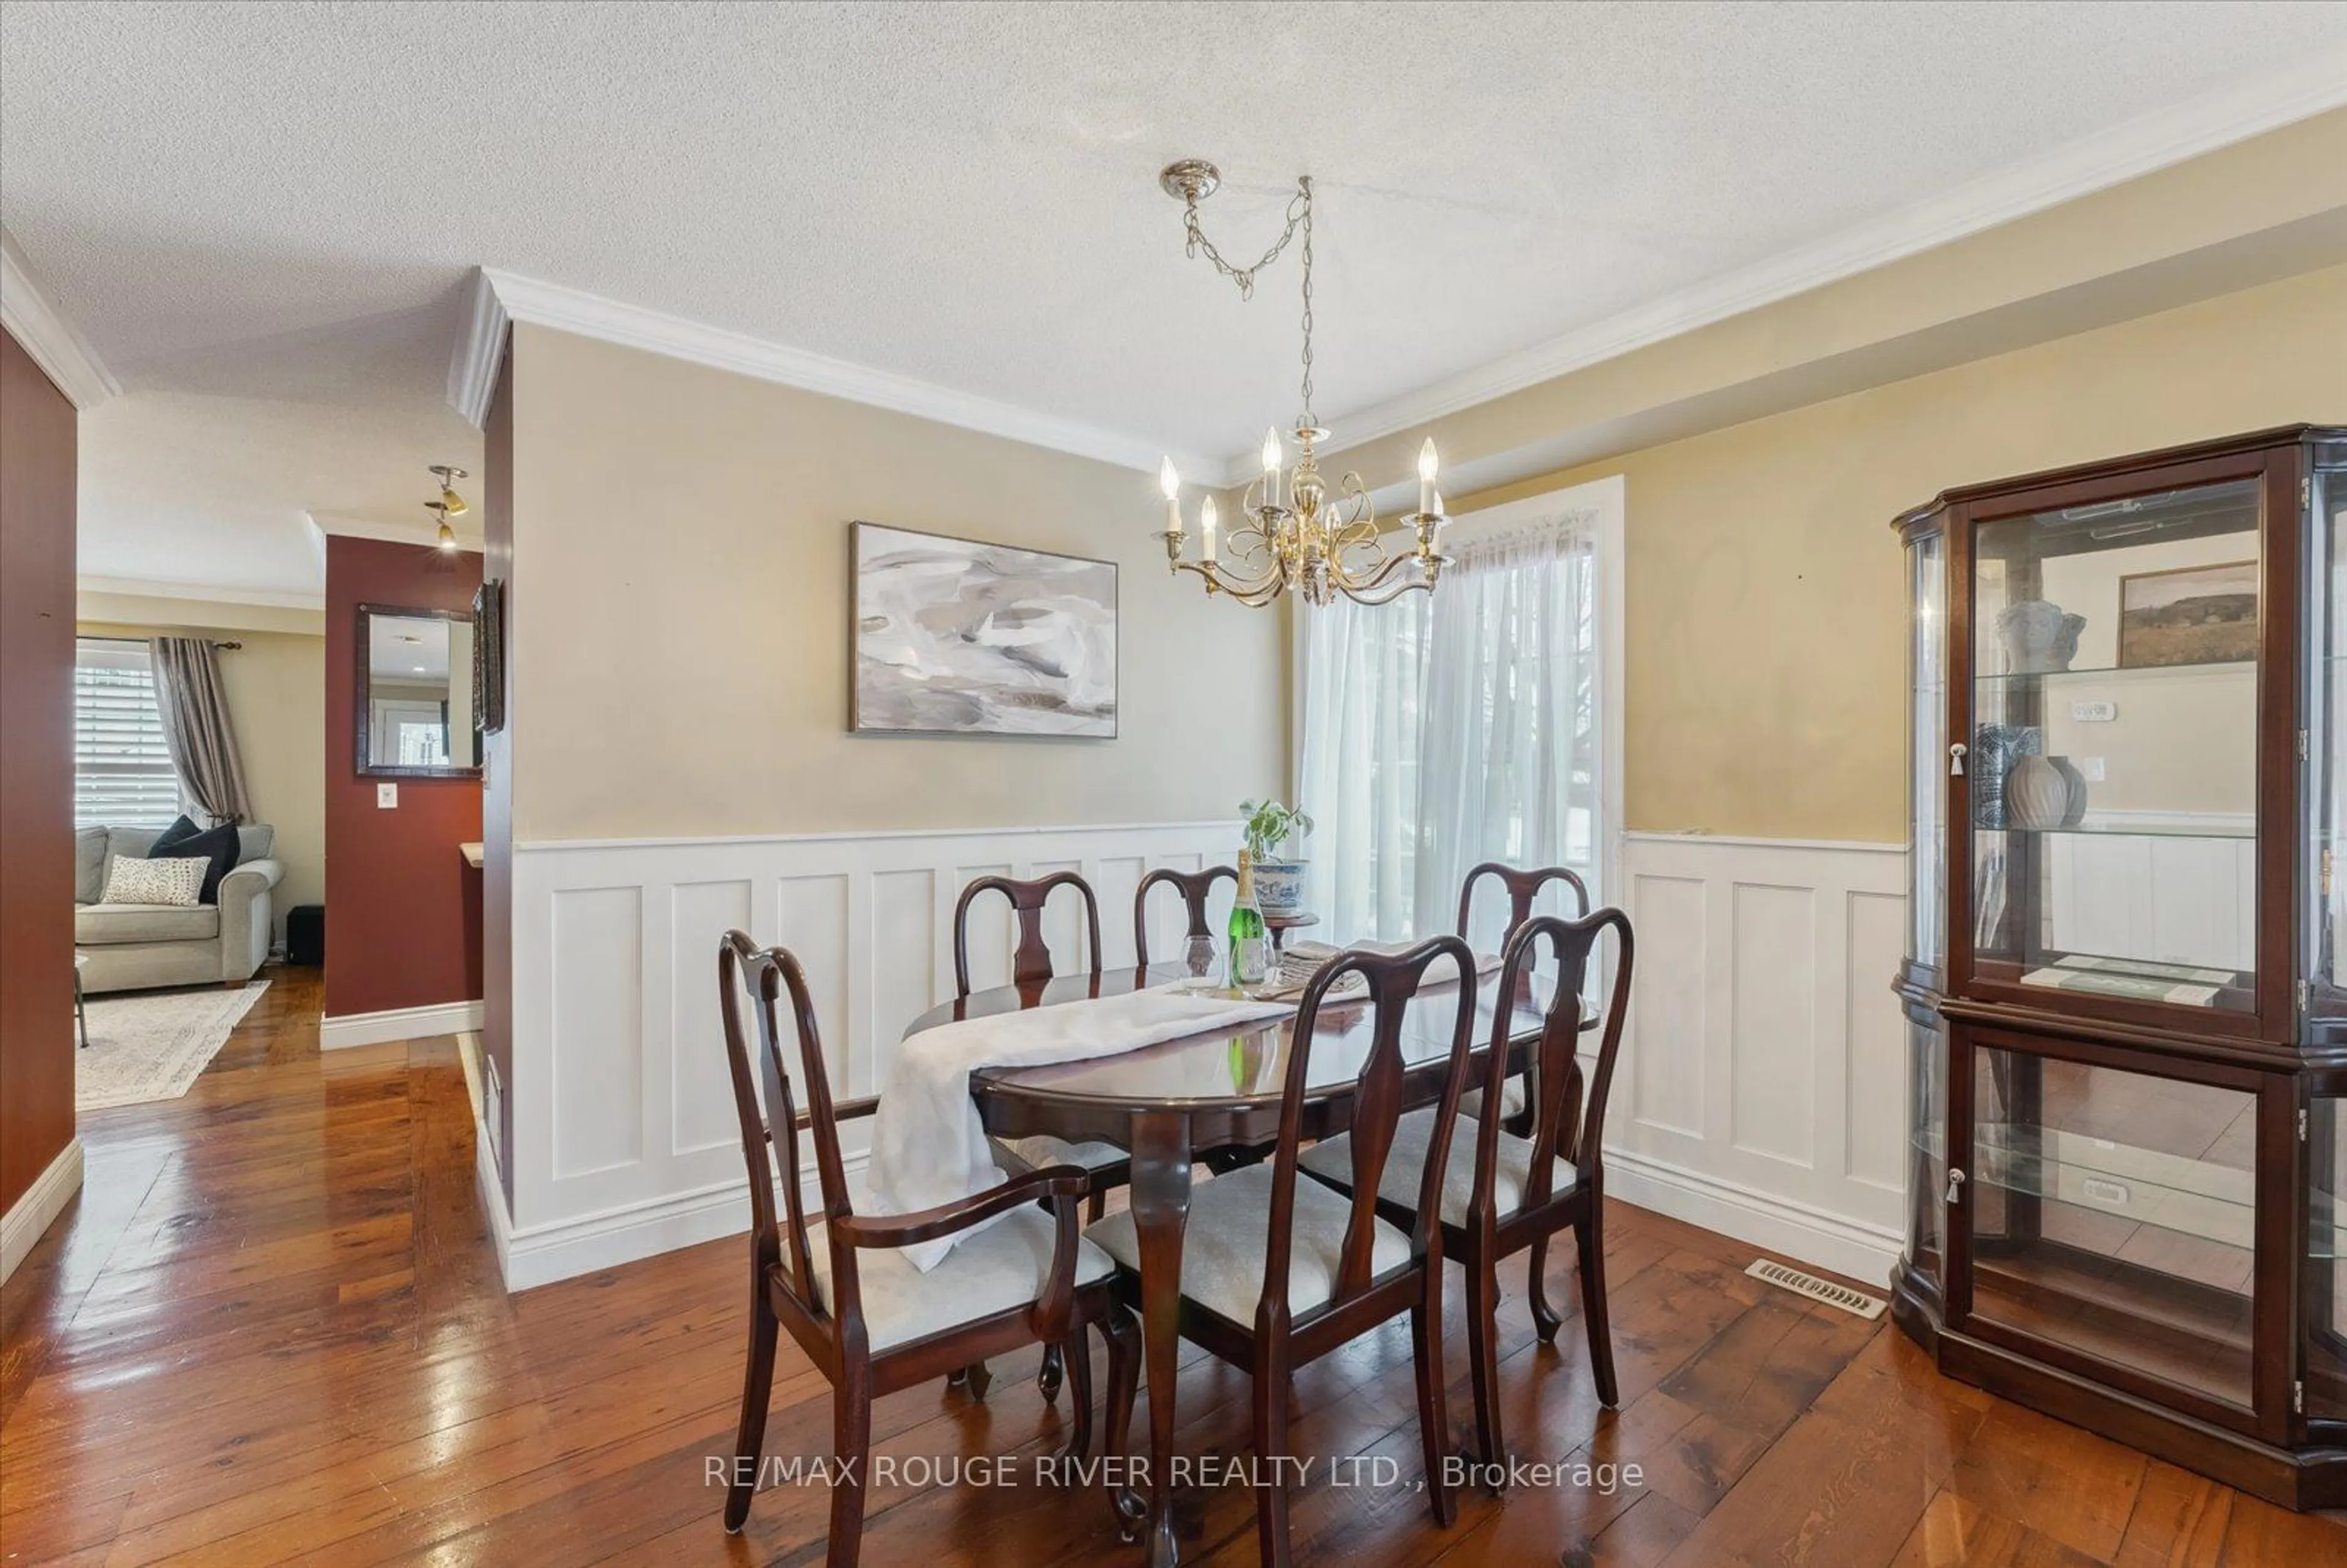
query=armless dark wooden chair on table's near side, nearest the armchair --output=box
[1084,937,1476,1566]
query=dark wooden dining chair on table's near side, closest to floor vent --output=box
[1305,909,1636,1474]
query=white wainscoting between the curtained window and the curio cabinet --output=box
[1606,833,1906,1284]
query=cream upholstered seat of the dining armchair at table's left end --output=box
[807,1209,1115,1352]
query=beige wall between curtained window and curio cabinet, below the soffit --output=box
[1450,268,2347,843]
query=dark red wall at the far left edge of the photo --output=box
[0,331,75,1211]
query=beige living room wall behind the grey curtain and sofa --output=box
[78,601,326,937]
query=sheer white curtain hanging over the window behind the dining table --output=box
[1300,511,1603,948]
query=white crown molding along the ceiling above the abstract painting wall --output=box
[448,268,1221,474]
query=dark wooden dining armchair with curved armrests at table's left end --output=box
[718,932,1140,1568]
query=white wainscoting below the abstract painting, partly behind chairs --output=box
[500,821,1237,1289]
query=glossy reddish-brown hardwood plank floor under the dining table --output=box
[0,972,2347,1568]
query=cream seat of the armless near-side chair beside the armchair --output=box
[1084,1150,1398,1326]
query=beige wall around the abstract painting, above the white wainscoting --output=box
[509,326,1286,843]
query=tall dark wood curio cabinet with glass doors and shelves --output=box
[1892,427,2347,1507]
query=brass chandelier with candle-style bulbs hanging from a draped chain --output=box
[1157,157,1450,606]
